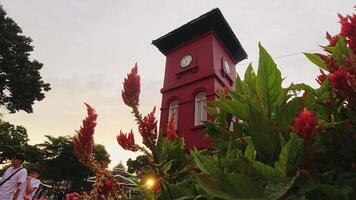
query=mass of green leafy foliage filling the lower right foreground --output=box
[125,21,356,200]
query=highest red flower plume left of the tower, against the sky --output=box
[121,63,140,108]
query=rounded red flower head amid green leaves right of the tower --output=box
[292,108,318,140]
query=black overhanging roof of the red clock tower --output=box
[152,8,247,62]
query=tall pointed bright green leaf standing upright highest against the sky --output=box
[256,44,284,117]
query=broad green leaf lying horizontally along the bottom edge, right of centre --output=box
[196,173,263,200]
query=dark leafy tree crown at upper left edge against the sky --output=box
[0,4,50,113]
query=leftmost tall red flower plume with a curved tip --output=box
[73,104,97,162]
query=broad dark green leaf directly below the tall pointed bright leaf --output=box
[248,108,280,164]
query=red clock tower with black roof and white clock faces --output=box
[152,9,247,149]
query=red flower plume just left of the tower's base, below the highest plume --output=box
[139,107,157,150]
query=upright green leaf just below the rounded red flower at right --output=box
[275,133,304,176]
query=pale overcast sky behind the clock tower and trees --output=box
[0,0,355,166]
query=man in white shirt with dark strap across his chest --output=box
[0,154,27,200]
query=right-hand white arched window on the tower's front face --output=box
[194,92,207,126]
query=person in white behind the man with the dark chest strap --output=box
[17,169,41,200]
